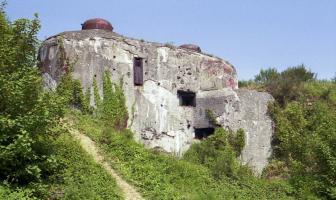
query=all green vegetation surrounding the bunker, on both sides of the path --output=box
[0,2,336,199]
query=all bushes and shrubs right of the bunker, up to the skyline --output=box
[241,65,336,199]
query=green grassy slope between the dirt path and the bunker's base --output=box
[68,109,291,199]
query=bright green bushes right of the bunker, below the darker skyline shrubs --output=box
[271,99,336,198]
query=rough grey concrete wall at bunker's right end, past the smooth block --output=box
[217,89,274,173]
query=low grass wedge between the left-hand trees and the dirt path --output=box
[0,127,123,200]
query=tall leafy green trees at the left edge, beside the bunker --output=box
[0,9,63,185]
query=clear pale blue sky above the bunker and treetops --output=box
[6,0,336,80]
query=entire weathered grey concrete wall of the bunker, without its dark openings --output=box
[39,30,272,171]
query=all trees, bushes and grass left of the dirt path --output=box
[0,5,121,200]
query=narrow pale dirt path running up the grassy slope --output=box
[68,126,143,200]
